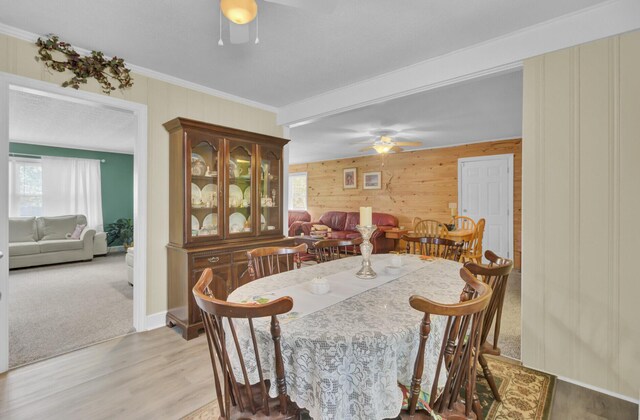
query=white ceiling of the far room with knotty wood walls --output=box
[289,71,522,163]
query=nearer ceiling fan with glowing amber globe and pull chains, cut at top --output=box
[218,0,338,46]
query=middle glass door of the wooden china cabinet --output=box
[227,140,255,236]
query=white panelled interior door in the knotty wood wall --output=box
[458,154,513,262]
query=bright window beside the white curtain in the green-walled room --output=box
[9,158,42,217]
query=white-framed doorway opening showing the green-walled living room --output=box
[0,75,147,371]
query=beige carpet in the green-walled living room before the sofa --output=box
[9,253,133,368]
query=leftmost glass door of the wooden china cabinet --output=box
[188,138,220,242]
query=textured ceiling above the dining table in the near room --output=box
[0,0,603,106]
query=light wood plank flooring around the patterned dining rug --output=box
[0,328,639,420]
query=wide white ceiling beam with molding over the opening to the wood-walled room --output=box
[277,0,640,127]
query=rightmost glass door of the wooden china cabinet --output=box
[258,148,283,233]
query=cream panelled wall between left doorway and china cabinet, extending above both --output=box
[0,35,282,315]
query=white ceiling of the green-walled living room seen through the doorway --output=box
[9,90,137,153]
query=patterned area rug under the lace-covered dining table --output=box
[182,356,556,420]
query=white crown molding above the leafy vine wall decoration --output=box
[0,23,278,114]
